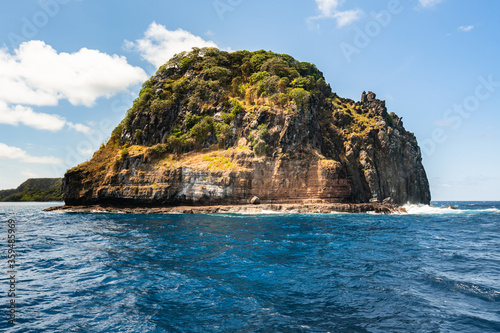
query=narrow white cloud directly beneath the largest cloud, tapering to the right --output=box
[0,101,90,133]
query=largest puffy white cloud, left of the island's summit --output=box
[0,40,147,106]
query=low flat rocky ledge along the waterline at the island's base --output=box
[44,203,406,214]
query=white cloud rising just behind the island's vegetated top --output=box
[125,22,217,68]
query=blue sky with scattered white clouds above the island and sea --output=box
[0,0,500,200]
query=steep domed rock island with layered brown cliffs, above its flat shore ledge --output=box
[63,49,430,206]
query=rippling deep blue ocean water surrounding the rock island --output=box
[0,202,500,332]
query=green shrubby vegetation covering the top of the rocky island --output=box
[111,48,334,154]
